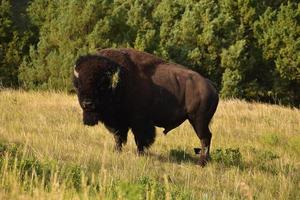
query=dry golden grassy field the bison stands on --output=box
[0,90,300,199]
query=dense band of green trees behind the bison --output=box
[0,0,300,107]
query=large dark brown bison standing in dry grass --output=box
[73,48,219,166]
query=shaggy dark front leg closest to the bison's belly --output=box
[132,122,156,154]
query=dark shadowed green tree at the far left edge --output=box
[0,0,37,87]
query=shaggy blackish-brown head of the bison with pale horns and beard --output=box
[73,55,121,126]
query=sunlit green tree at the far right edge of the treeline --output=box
[255,3,300,106]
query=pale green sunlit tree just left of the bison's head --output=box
[19,0,105,90]
